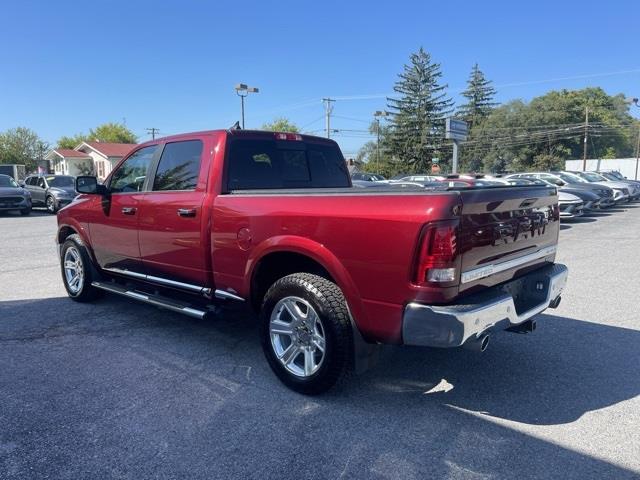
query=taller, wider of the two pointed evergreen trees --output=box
[387,47,453,172]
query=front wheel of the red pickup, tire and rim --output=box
[60,235,101,302]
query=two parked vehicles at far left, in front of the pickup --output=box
[0,175,77,215]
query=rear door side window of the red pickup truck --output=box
[153,140,202,190]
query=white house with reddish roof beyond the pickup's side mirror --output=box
[45,142,136,180]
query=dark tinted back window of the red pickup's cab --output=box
[227,139,349,190]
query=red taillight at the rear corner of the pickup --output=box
[413,220,458,285]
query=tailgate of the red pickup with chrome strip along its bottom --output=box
[458,186,560,293]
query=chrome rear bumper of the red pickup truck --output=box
[402,264,568,348]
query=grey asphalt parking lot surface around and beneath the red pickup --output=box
[0,205,640,480]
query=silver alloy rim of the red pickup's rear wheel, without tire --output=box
[269,297,326,378]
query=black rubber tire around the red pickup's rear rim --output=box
[260,273,353,395]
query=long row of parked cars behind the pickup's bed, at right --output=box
[352,171,640,218]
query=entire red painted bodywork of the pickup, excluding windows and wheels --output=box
[58,131,558,343]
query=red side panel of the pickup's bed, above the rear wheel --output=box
[212,193,458,340]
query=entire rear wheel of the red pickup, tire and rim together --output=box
[261,273,353,395]
